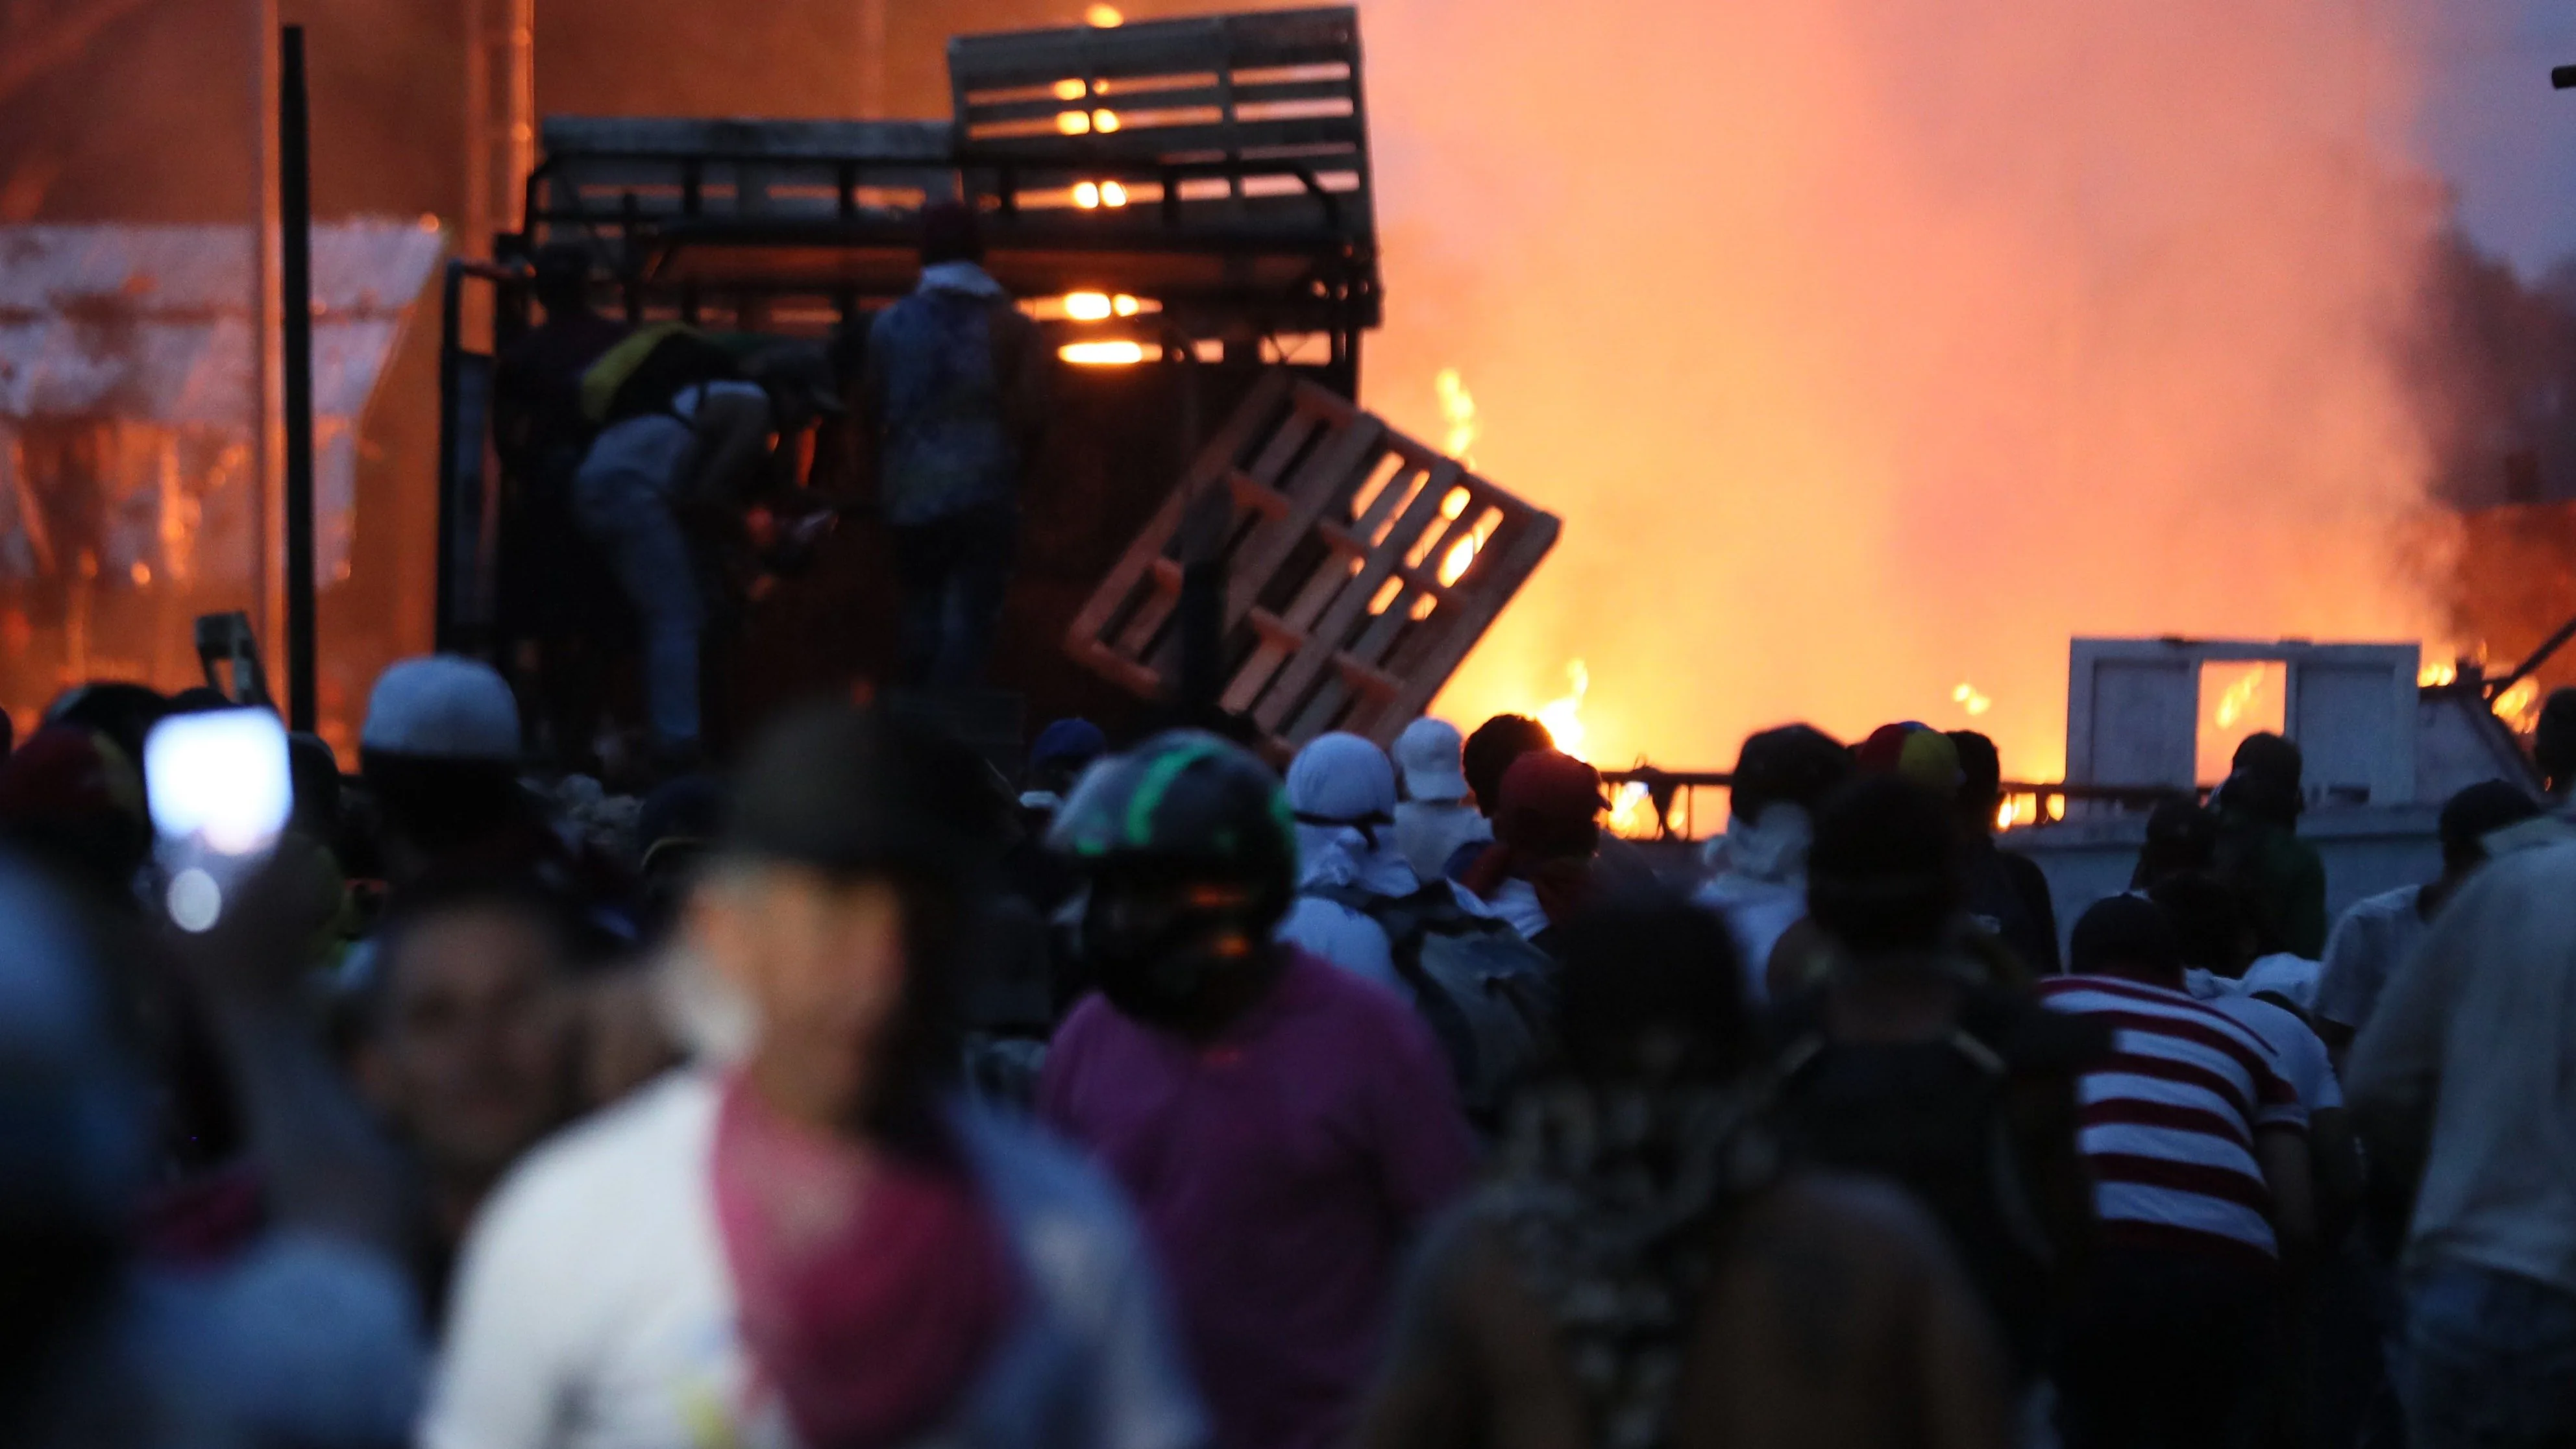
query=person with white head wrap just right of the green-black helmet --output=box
[1278,731,1422,999]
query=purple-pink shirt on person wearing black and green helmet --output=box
[1038,953,1473,1449]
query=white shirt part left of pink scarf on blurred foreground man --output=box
[420,1073,796,1449]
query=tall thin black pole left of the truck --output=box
[278,26,314,733]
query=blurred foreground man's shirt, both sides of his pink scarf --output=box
[420,1073,1205,1449]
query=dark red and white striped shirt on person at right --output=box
[2040,975,2308,1258]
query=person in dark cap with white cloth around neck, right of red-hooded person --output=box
[1695,725,1852,1001]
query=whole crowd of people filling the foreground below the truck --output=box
[0,656,2576,1449]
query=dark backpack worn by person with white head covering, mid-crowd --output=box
[1306,880,1558,1125]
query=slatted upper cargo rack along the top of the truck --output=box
[508,8,1380,373]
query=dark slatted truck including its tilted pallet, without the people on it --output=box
[438,8,1558,751]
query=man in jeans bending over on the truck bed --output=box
[572,339,845,772]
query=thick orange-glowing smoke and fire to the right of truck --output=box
[1363,0,2437,777]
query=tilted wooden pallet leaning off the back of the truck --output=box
[1066,371,1558,751]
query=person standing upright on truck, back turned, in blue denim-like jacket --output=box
[861,201,1051,687]
